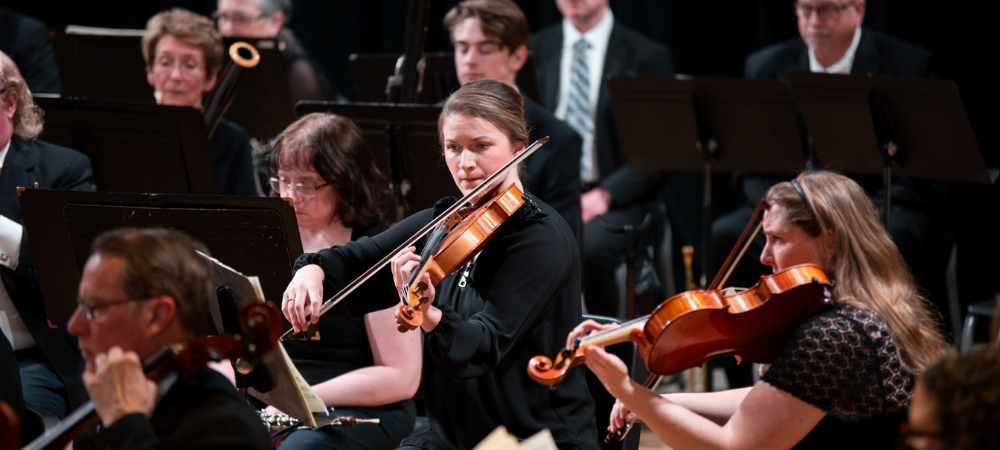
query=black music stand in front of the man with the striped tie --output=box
[608,77,806,282]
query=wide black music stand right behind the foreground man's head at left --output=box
[19,189,302,328]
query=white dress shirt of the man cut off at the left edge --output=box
[0,141,36,350]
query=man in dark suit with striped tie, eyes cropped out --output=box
[532,0,674,315]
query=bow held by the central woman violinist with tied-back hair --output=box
[280,136,549,341]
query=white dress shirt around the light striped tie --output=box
[556,9,615,183]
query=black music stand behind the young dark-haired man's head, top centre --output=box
[350,52,542,105]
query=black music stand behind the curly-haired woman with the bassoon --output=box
[52,33,293,140]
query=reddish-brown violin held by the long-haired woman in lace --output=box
[528,264,832,386]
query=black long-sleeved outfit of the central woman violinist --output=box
[298,194,598,450]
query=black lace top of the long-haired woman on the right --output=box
[762,305,913,450]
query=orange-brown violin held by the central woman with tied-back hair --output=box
[399,184,524,331]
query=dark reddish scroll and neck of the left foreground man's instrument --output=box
[23,301,281,450]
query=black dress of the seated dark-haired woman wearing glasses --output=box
[281,222,417,450]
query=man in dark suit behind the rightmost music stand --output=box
[712,0,953,346]
